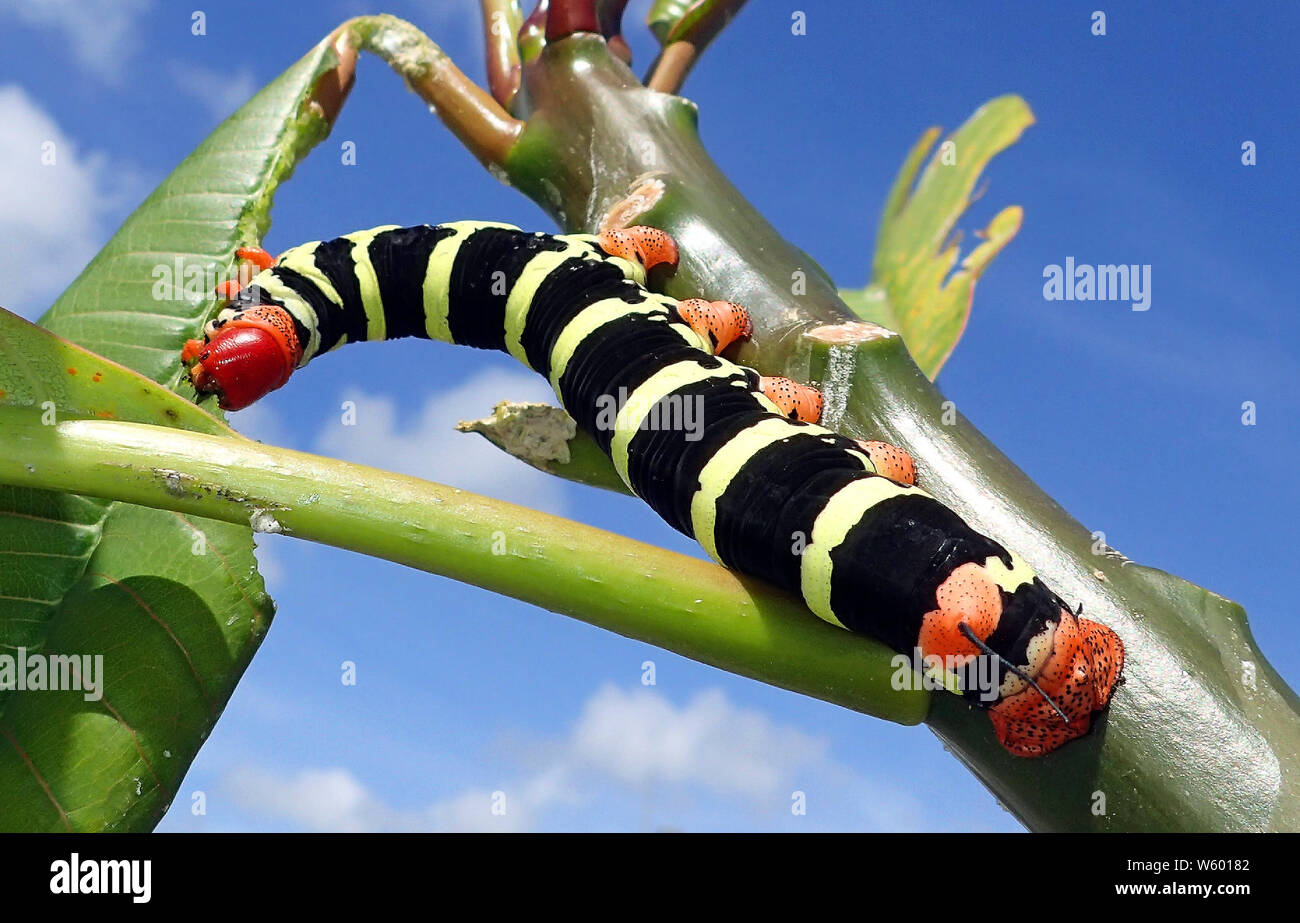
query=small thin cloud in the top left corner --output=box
[0,0,153,83]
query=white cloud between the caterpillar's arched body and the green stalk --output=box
[315,369,564,514]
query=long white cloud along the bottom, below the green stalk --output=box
[215,685,926,831]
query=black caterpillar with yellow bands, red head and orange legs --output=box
[182,221,1125,757]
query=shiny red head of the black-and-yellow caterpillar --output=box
[181,304,303,411]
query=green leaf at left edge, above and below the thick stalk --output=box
[0,311,272,831]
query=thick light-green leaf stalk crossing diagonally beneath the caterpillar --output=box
[0,407,931,724]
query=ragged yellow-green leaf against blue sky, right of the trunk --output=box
[840,96,1034,378]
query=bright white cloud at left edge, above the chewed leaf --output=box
[0,85,131,317]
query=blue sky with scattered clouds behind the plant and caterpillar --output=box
[0,0,1300,831]
